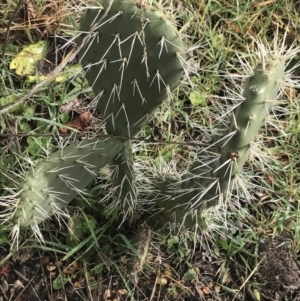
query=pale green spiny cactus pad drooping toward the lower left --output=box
[13,138,123,227]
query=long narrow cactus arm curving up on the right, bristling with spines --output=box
[156,57,286,228]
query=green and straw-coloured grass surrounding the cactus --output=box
[0,0,300,301]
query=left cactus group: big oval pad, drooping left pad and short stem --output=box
[1,0,185,244]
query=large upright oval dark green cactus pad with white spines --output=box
[77,0,185,137]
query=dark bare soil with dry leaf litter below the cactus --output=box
[0,236,300,301]
